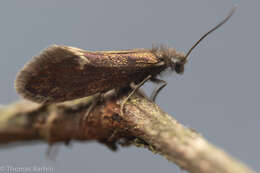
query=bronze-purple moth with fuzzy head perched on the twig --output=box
[15,7,236,107]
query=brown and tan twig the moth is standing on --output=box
[0,90,253,173]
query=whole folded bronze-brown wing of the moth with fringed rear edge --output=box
[15,45,158,103]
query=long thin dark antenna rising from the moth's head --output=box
[185,5,237,59]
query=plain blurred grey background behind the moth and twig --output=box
[0,0,260,173]
